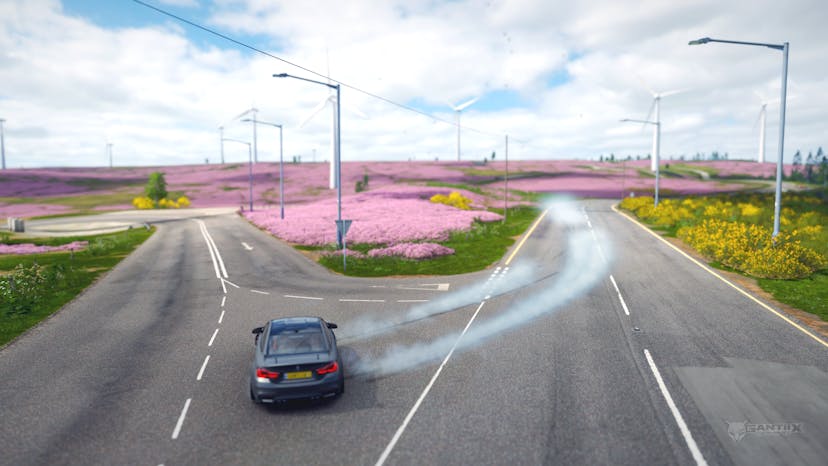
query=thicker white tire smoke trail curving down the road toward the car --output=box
[354,201,610,376]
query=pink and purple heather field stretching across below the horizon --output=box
[0,160,790,253]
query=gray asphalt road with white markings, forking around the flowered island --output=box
[0,201,828,465]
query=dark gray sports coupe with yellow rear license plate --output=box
[250,317,345,403]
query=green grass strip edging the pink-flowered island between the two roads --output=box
[314,206,539,277]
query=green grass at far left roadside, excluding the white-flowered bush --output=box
[0,228,155,346]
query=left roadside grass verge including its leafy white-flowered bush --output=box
[0,228,155,346]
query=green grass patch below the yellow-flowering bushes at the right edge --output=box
[757,269,828,322]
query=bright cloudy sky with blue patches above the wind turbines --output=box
[0,0,828,168]
